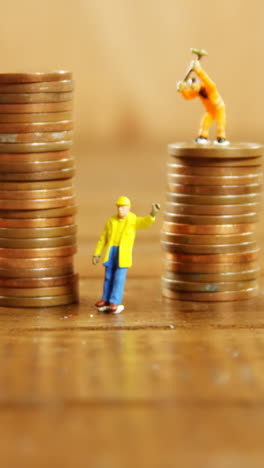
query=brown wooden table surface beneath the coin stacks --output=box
[0,148,264,468]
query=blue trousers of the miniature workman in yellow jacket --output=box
[102,245,127,305]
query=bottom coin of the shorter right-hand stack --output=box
[162,287,258,302]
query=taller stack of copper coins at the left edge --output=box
[0,71,78,307]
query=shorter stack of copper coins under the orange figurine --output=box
[161,143,263,301]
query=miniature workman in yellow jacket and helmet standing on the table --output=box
[92,196,160,313]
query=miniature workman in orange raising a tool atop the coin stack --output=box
[177,49,229,145]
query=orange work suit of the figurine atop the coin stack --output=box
[180,66,226,139]
